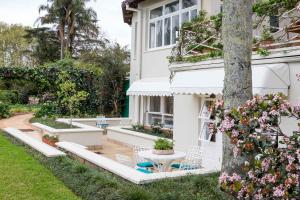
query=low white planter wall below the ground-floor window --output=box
[107,126,171,147]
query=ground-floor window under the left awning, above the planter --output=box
[146,97,173,128]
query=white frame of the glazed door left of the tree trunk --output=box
[198,98,216,142]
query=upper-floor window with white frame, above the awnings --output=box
[149,0,198,48]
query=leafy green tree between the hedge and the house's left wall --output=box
[80,43,130,116]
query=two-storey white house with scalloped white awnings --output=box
[122,0,300,170]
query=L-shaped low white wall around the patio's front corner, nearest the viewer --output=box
[56,142,215,184]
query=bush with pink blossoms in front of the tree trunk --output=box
[216,95,300,199]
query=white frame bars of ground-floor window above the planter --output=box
[146,96,174,126]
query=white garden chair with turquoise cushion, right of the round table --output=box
[171,146,202,170]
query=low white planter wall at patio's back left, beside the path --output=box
[32,122,104,147]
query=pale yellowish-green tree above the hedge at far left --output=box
[0,22,35,67]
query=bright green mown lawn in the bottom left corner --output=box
[0,133,79,200]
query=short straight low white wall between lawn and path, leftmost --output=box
[4,128,66,157]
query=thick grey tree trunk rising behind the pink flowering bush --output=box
[222,0,253,174]
